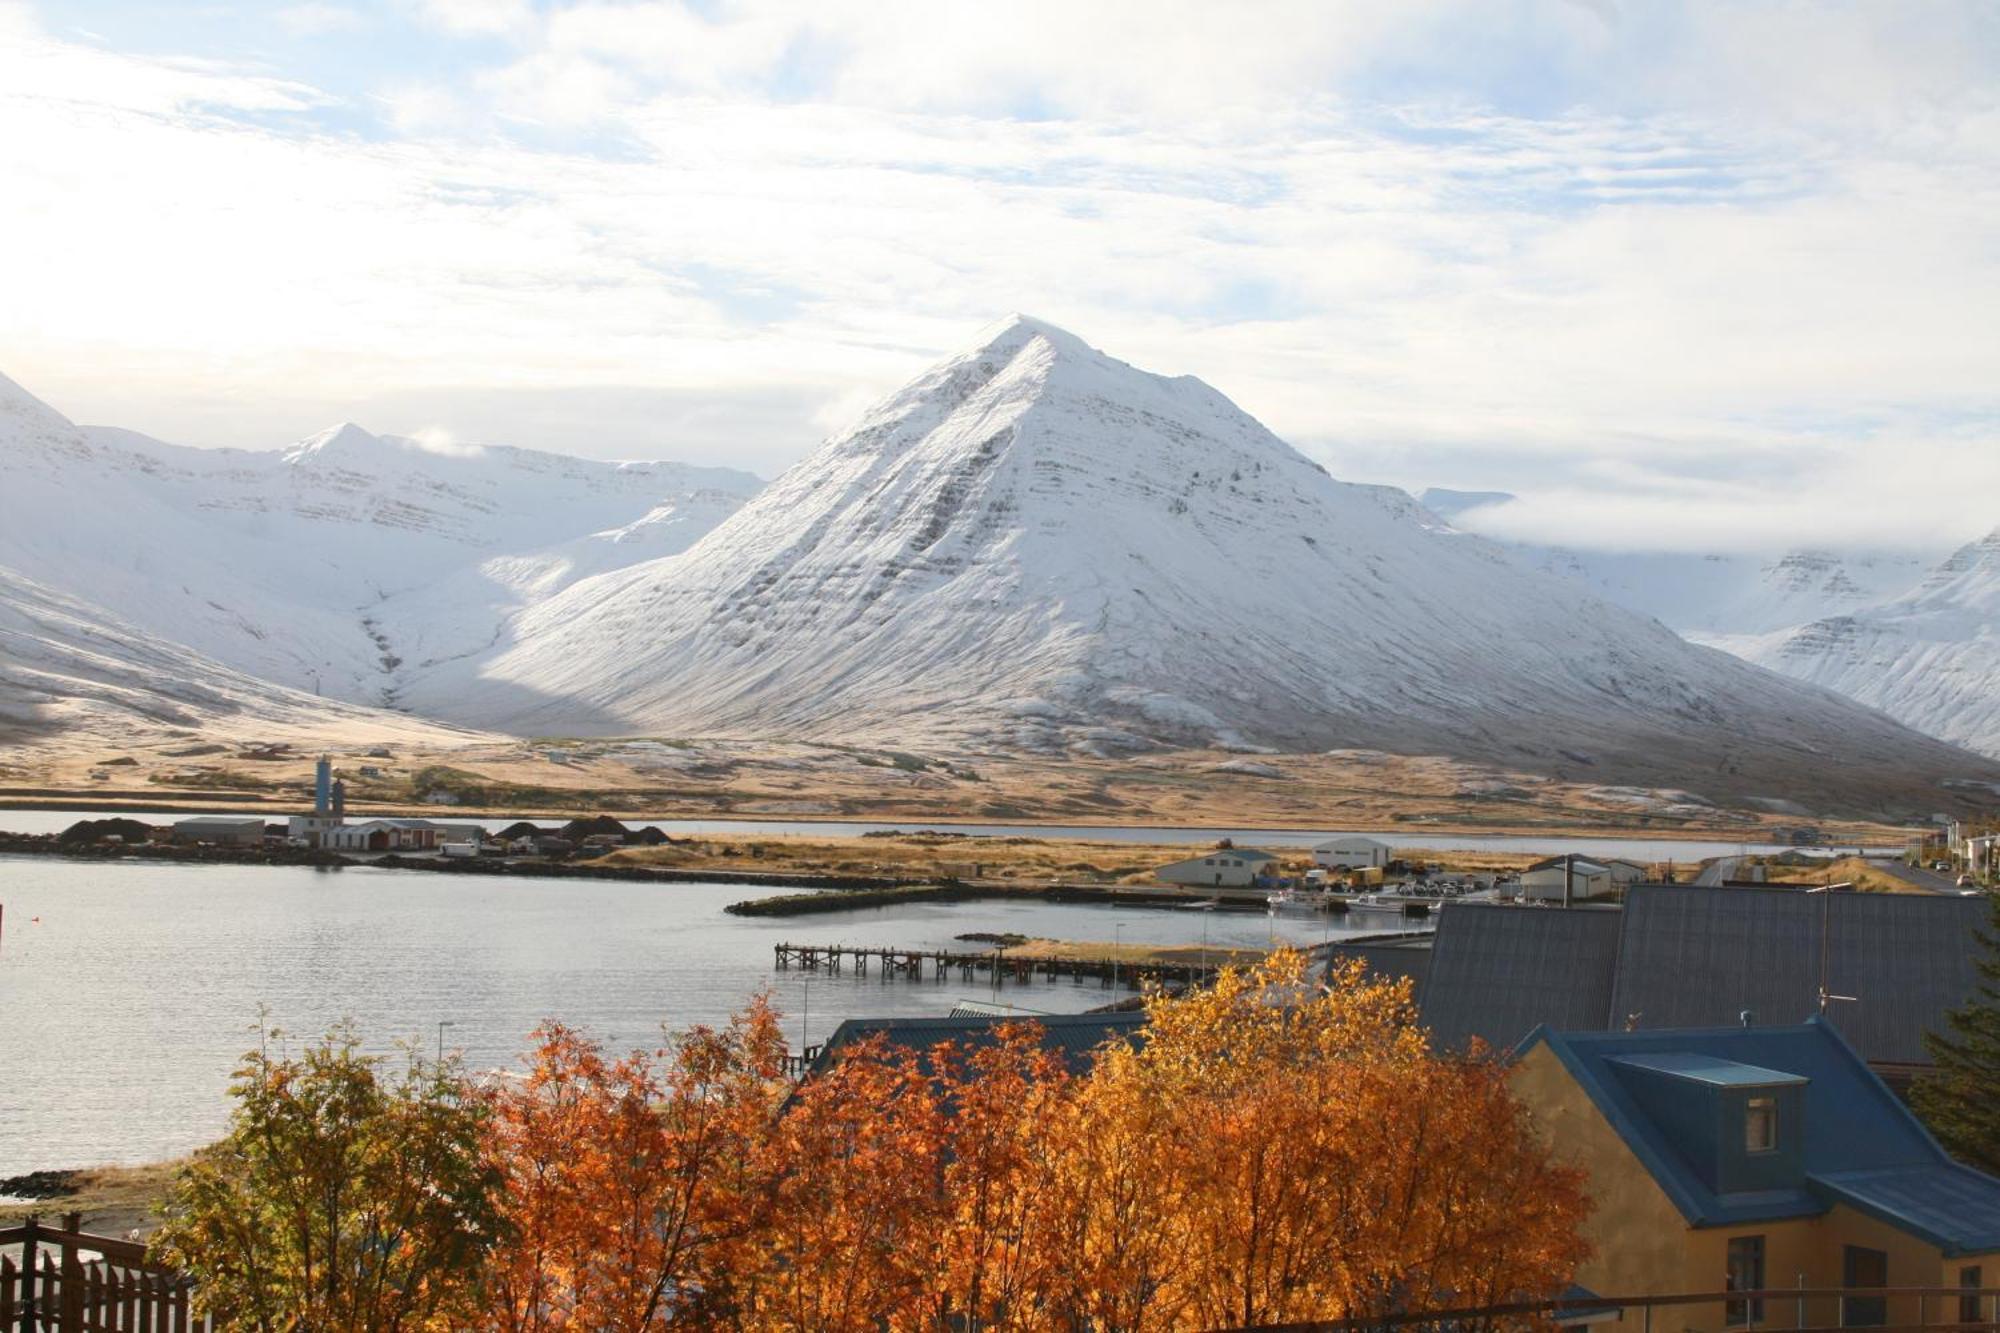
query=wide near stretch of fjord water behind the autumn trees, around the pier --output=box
[0,857,1400,1177]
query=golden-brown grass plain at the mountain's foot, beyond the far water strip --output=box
[0,729,1902,843]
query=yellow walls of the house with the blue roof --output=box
[1510,1045,2000,1333]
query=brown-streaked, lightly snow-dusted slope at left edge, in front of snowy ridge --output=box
[0,568,472,751]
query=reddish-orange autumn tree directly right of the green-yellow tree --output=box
[486,999,784,1333]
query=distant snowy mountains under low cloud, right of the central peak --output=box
[1424,488,2000,757]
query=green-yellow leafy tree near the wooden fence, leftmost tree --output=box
[152,1025,500,1333]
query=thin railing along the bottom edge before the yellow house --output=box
[1238,1287,2000,1333]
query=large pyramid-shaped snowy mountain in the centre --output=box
[406,318,1990,809]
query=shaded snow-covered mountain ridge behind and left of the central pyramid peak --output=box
[0,376,762,705]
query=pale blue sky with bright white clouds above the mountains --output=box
[0,0,2000,548]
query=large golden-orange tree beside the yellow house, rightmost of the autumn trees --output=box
[1076,953,1588,1329]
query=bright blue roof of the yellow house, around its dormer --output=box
[1516,1019,2000,1255]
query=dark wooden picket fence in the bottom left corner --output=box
[0,1213,214,1333]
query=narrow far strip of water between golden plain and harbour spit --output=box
[0,807,1902,861]
